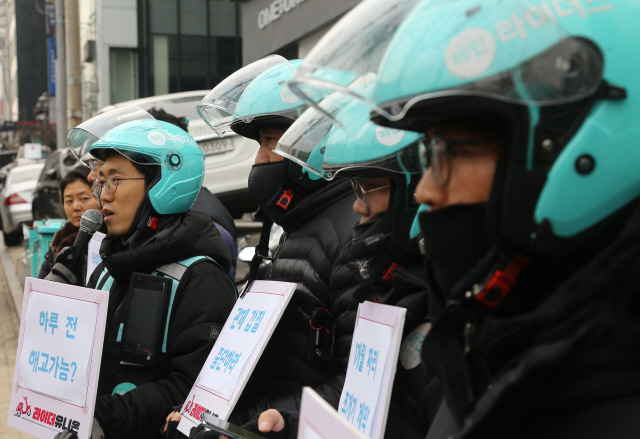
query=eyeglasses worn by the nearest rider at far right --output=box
[418,136,481,187]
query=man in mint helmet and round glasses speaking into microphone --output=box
[49,106,235,439]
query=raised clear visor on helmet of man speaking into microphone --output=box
[67,105,184,169]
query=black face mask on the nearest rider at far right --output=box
[419,203,493,297]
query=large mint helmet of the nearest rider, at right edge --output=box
[373,0,640,256]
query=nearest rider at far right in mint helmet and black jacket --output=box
[370,1,640,439]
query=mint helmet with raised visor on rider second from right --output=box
[275,82,422,266]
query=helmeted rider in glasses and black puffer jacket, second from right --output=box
[232,87,441,438]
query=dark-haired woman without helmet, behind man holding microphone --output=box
[38,166,101,279]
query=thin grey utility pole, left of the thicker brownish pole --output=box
[55,0,67,149]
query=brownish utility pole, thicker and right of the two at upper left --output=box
[64,0,82,129]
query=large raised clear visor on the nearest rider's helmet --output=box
[290,0,604,126]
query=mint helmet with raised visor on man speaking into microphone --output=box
[67,106,204,215]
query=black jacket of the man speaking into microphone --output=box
[89,212,235,438]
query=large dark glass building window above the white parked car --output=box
[138,0,242,96]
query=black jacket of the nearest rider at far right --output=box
[423,201,640,439]
